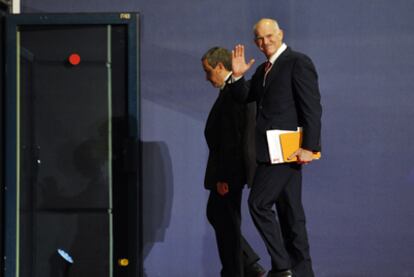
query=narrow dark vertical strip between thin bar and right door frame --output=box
[112,25,133,276]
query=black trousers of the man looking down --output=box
[207,185,259,277]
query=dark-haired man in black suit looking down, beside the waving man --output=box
[201,47,266,277]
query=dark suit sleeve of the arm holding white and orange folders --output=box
[292,56,322,151]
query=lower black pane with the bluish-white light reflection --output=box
[20,212,109,277]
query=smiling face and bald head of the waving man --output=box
[254,22,283,58]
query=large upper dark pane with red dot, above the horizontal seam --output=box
[20,26,109,209]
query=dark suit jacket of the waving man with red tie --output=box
[229,47,322,162]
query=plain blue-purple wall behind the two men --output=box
[23,0,414,277]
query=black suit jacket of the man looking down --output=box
[204,85,246,190]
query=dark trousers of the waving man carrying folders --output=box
[248,164,314,277]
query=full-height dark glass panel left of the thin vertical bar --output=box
[17,25,112,277]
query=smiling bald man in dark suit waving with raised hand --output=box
[229,19,322,277]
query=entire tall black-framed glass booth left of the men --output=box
[2,14,141,277]
